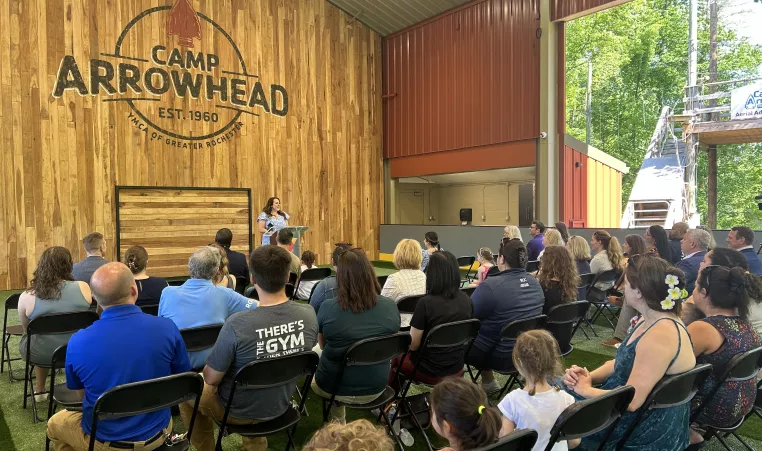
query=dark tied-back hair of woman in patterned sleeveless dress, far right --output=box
[696,265,749,319]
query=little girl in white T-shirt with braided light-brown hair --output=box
[497,330,580,451]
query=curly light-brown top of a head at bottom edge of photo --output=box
[302,420,394,451]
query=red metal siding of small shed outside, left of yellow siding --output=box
[559,146,594,227]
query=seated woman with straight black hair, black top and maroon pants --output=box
[389,251,473,388]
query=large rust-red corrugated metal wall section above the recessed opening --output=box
[383,0,540,158]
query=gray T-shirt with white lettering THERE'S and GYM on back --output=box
[206,301,318,420]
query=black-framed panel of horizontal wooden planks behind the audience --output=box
[117,188,250,277]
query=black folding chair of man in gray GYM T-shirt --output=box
[215,351,320,451]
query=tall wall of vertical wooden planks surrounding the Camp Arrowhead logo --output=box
[0,0,384,290]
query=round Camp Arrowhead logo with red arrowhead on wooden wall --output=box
[52,0,288,149]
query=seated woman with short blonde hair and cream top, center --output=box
[381,239,426,306]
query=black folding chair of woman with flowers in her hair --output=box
[617,364,712,450]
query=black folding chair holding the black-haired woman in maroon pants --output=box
[388,318,481,451]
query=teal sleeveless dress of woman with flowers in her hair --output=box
[570,318,692,451]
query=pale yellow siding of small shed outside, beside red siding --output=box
[587,158,622,228]
